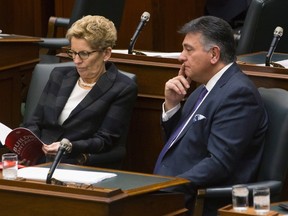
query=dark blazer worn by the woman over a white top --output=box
[24,62,137,167]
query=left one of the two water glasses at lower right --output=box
[232,185,249,211]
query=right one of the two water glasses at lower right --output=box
[253,187,270,215]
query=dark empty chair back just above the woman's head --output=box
[69,0,125,30]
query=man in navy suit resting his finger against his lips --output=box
[154,16,268,215]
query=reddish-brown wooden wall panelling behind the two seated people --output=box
[0,0,204,51]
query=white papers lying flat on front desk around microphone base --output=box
[18,167,117,184]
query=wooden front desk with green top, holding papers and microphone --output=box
[0,164,188,216]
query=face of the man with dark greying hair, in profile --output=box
[179,33,213,83]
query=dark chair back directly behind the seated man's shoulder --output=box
[258,87,288,182]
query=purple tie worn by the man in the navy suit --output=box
[154,86,208,173]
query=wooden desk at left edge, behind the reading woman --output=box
[0,34,40,128]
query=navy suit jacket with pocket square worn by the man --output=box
[157,63,268,214]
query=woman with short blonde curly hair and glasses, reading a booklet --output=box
[25,15,137,168]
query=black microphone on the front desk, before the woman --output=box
[46,138,72,184]
